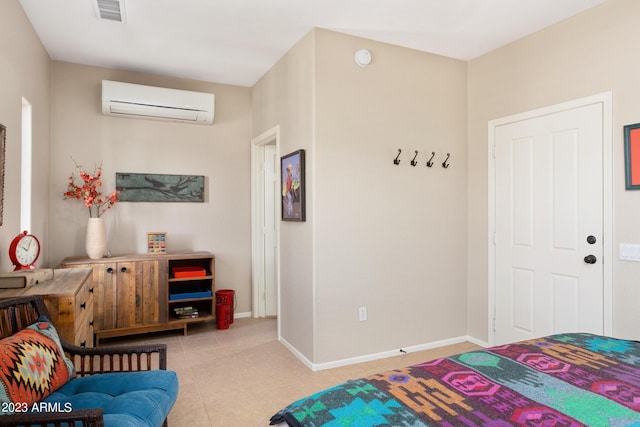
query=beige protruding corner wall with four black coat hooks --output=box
[253,30,467,364]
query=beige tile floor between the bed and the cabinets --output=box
[104,318,478,427]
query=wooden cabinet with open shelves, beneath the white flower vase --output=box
[60,252,215,346]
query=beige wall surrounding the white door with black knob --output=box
[467,0,640,339]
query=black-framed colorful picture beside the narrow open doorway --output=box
[280,150,305,221]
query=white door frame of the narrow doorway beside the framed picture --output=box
[251,126,280,324]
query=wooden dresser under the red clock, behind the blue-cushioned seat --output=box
[0,268,94,347]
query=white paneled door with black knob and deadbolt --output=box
[490,99,604,344]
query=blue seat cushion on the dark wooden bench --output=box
[44,370,178,427]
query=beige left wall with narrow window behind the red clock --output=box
[0,1,50,271]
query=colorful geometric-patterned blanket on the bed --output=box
[271,334,640,427]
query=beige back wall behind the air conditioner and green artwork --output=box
[50,62,251,312]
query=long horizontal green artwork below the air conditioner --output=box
[116,172,204,202]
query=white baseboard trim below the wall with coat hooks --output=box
[279,335,489,372]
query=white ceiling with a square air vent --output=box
[19,0,605,86]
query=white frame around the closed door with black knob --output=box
[487,92,613,345]
